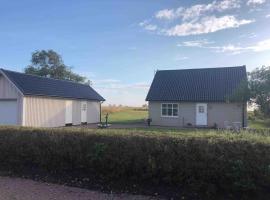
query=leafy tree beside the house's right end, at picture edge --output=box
[248,66,270,117]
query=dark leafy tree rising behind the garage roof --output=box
[24,50,87,83]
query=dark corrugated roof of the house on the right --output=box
[146,66,247,102]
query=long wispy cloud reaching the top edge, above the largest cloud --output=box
[155,0,240,20]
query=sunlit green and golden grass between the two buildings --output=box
[102,108,148,124]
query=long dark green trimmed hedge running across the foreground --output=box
[0,127,270,198]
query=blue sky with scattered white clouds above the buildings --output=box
[0,0,270,106]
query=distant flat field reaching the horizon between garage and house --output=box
[102,107,148,124]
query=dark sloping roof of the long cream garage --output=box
[1,69,105,101]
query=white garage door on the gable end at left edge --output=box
[0,100,17,125]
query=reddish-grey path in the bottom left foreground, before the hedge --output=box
[0,177,159,200]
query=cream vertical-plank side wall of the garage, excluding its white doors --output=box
[24,96,100,127]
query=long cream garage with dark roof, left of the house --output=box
[0,69,105,127]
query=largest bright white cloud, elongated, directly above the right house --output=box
[162,15,254,36]
